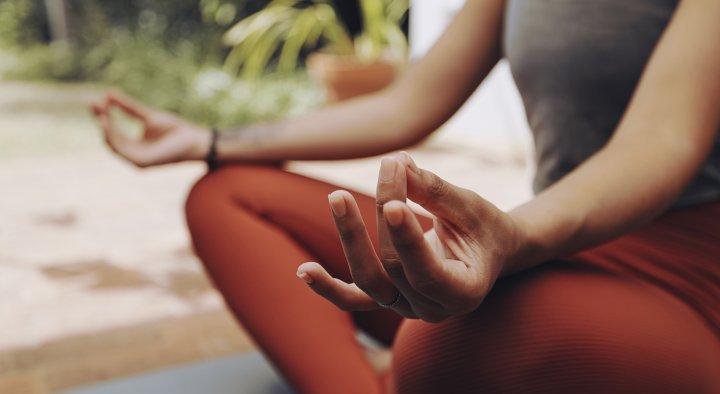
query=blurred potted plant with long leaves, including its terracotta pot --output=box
[224,0,408,101]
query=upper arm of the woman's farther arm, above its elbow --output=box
[391,0,505,137]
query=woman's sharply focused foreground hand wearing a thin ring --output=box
[298,152,525,322]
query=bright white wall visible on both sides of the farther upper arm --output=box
[410,0,531,161]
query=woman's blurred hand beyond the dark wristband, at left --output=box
[91,93,210,167]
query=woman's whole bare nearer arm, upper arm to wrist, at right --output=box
[507,1,720,272]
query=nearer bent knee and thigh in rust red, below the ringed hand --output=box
[393,270,720,393]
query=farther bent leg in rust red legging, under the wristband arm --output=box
[186,165,432,393]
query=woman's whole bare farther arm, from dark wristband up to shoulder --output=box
[218,0,504,161]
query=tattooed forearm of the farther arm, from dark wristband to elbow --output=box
[217,88,428,161]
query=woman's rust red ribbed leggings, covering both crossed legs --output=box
[187,165,720,393]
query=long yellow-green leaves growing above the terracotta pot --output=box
[223,0,409,77]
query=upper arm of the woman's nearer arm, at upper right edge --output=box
[613,0,720,160]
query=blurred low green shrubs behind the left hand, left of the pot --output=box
[0,32,322,126]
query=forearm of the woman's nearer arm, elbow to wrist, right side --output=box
[506,132,709,273]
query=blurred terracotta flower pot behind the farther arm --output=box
[306,53,397,102]
